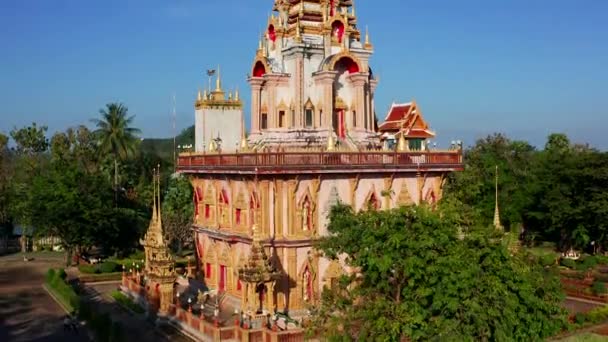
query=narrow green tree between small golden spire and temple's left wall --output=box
[162,176,194,253]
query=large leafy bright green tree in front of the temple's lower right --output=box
[314,202,564,341]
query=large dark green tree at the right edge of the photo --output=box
[524,134,608,250]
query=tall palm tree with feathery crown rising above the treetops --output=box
[92,103,141,198]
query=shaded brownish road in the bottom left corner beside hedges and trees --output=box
[0,255,88,342]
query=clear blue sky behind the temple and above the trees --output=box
[0,0,608,149]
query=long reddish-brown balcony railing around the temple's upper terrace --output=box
[177,150,462,173]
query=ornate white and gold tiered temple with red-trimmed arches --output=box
[178,0,463,326]
